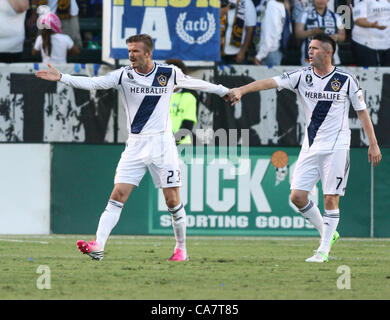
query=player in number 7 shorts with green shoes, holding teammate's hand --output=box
[228,35,382,262]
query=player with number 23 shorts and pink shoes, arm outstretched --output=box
[36,34,228,261]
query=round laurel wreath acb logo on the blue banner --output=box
[176,12,216,44]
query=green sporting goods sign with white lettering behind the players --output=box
[149,147,322,235]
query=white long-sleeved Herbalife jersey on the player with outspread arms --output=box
[60,63,229,134]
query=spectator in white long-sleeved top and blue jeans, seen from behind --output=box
[254,0,290,66]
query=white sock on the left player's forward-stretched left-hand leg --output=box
[96,199,123,250]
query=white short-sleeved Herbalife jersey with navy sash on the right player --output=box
[273,67,366,151]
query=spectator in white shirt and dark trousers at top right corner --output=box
[351,0,390,66]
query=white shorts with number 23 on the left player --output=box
[114,133,181,188]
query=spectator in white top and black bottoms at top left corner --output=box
[0,0,29,63]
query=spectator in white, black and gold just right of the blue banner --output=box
[220,0,256,64]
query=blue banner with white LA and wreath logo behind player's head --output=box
[110,0,220,61]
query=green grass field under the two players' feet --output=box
[0,235,390,300]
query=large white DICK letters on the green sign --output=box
[158,158,272,212]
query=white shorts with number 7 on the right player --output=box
[290,149,349,196]
